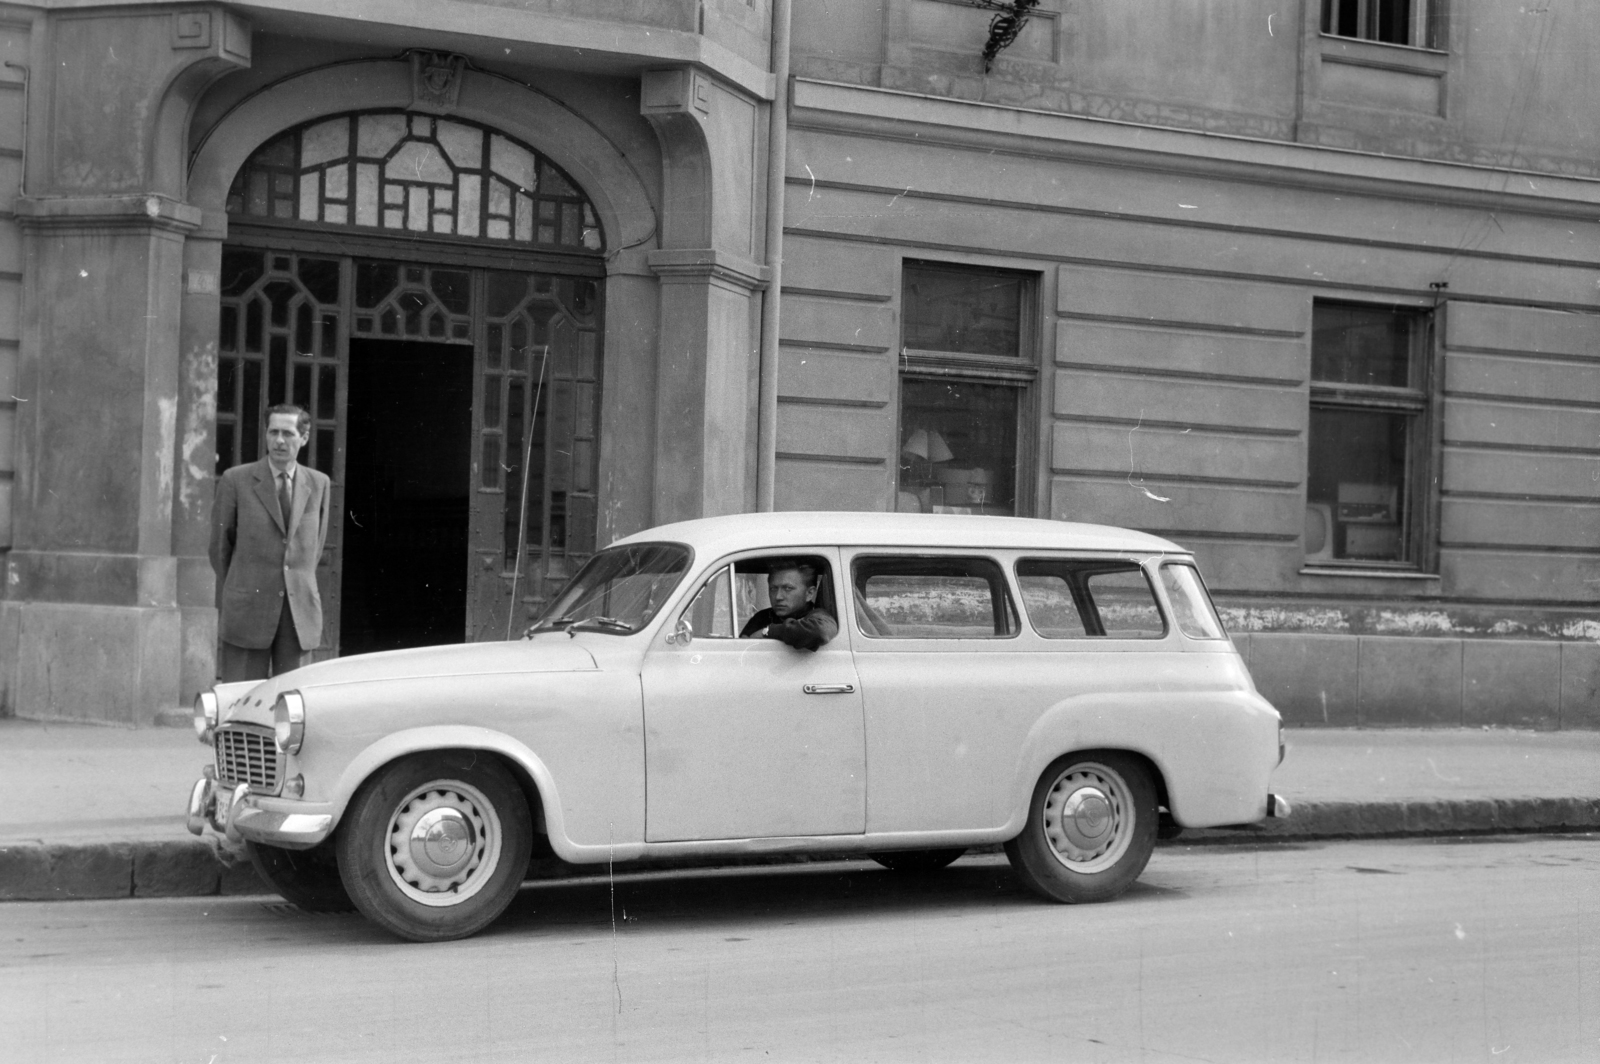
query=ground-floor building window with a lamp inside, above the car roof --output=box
[894,261,1038,514]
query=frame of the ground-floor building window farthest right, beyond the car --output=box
[1299,296,1443,574]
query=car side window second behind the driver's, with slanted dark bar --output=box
[1016,558,1166,638]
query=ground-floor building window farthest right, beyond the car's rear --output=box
[1306,302,1432,568]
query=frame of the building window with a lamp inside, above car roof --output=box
[896,256,1043,518]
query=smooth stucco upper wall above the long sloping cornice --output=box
[794,0,1600,176]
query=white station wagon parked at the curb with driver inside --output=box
[189,514,1288,941]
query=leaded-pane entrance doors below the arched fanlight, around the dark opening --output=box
[218,246,600,656]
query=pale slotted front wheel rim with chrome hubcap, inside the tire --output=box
[386,779,501,906]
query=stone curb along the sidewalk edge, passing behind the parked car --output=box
[0,798,1600,901]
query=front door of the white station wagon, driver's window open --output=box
[642,549,866,842]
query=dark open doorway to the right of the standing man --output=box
[339,339,472,654]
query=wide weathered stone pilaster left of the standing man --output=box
[5,195,200,723]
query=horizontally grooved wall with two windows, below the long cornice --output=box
[778,82,1600,675]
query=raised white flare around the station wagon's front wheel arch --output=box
[330,725,645,862]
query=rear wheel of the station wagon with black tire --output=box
[1005,750,1157,902]
